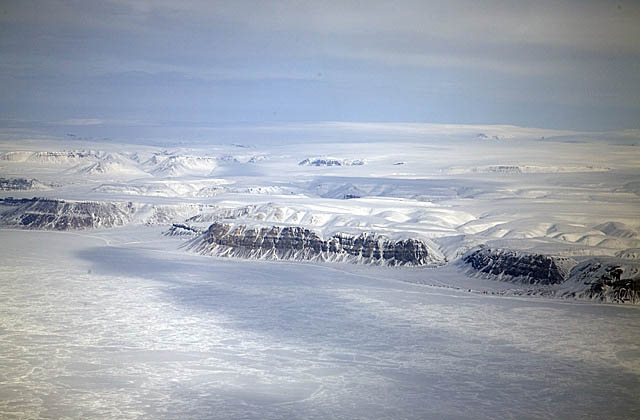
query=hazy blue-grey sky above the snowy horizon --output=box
[0,0,640,130]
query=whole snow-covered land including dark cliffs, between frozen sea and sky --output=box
[0,127,640,302]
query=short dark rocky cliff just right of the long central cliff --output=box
[462,247,575,285]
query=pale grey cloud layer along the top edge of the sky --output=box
[117,0,640,54]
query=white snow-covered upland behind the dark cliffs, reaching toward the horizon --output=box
[0,128,640,260]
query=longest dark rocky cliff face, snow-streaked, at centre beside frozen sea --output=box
[191,223,441,266]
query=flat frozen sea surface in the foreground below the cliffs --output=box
[0,229,640,419]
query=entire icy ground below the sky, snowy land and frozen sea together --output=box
[0,125,640,419]
